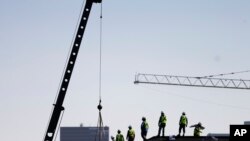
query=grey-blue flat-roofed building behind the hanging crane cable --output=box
[60,127,109,141]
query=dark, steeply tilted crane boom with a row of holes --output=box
[44,0,102,141]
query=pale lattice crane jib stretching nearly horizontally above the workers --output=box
[134,73,250,90]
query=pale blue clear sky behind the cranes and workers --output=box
[0,0,250,141]
